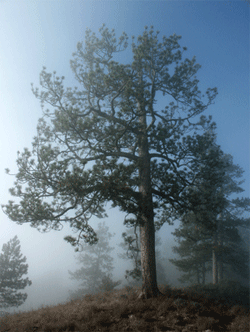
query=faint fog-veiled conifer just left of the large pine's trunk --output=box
[68,223,121,300]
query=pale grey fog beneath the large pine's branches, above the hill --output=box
[1,205,188,312]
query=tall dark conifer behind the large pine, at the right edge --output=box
[171,133,250,284]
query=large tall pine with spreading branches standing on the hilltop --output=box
[3,25,217,298]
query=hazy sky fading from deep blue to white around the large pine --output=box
[0,0,250,312]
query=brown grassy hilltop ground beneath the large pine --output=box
[0,284,250,332]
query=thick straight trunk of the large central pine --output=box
[139,105,163,298]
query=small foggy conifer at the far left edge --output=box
[0,236,32,308]
